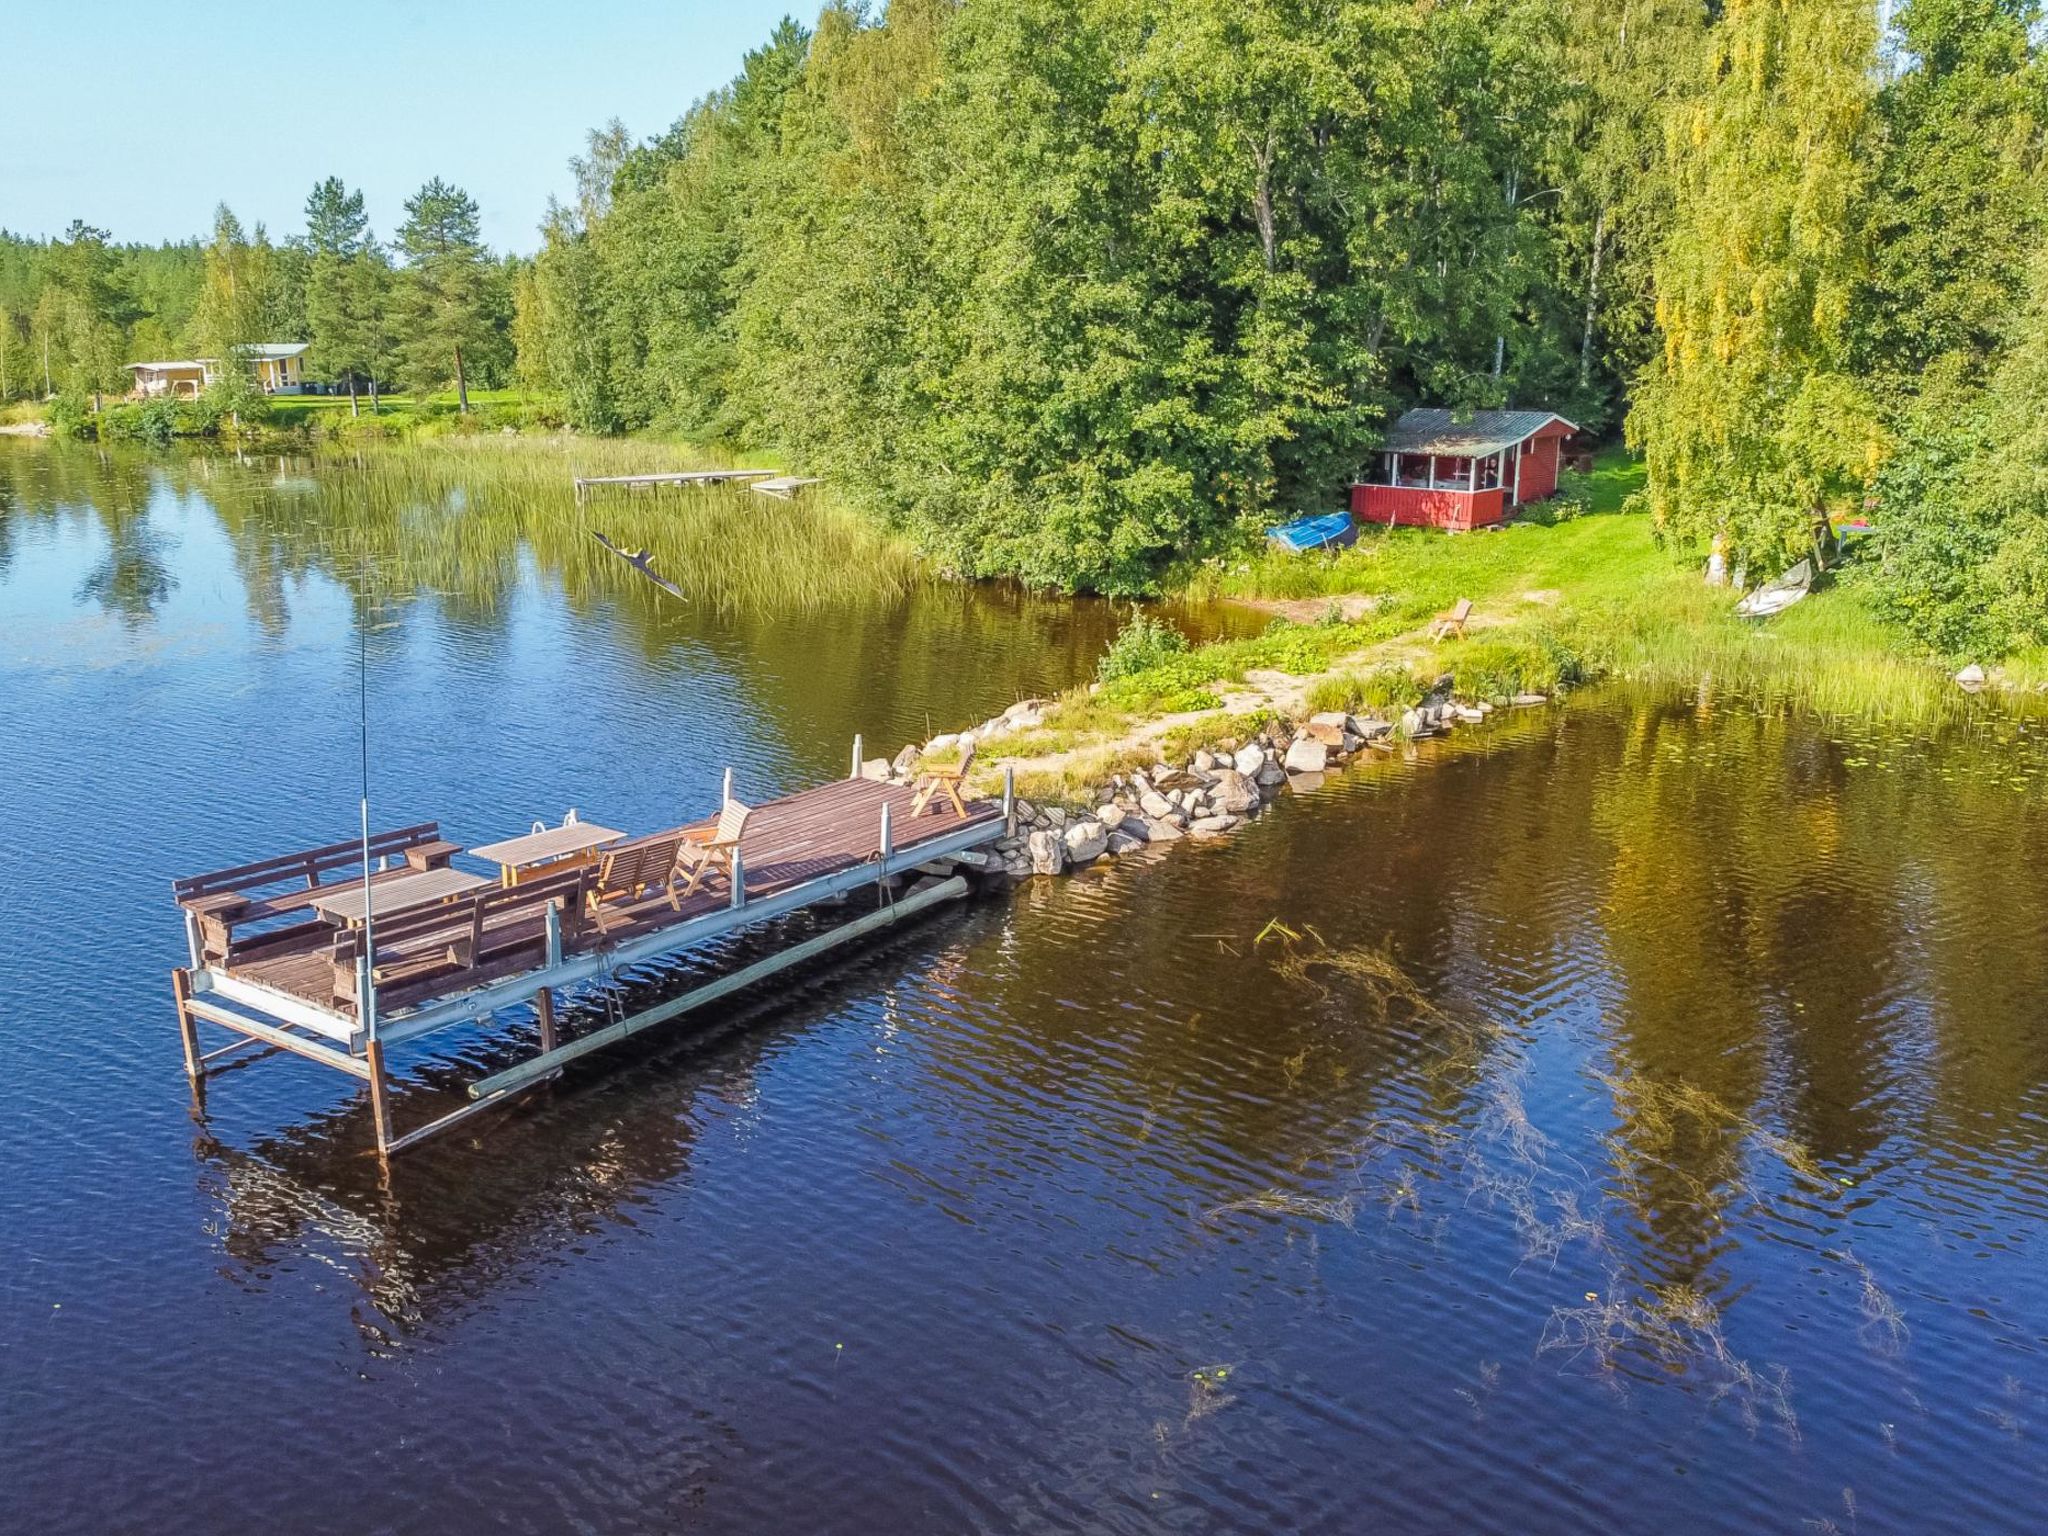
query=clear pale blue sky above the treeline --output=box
[14,0,798,252]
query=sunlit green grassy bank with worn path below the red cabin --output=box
[962,453,2048,797]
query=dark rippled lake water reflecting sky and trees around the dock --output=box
[0,442,2048,1536]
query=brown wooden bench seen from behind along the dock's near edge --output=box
[330,864,594,1010]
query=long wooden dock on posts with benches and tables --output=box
[172,765,1014,1153]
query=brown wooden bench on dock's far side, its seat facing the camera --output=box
[170,821,461,965]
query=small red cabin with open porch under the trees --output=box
[1352,410,1579,530]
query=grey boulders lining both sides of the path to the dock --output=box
[860,680,1548,883]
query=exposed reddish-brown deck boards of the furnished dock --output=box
[225,778,1001,1018]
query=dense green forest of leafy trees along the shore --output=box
[0,0,2048,651]
